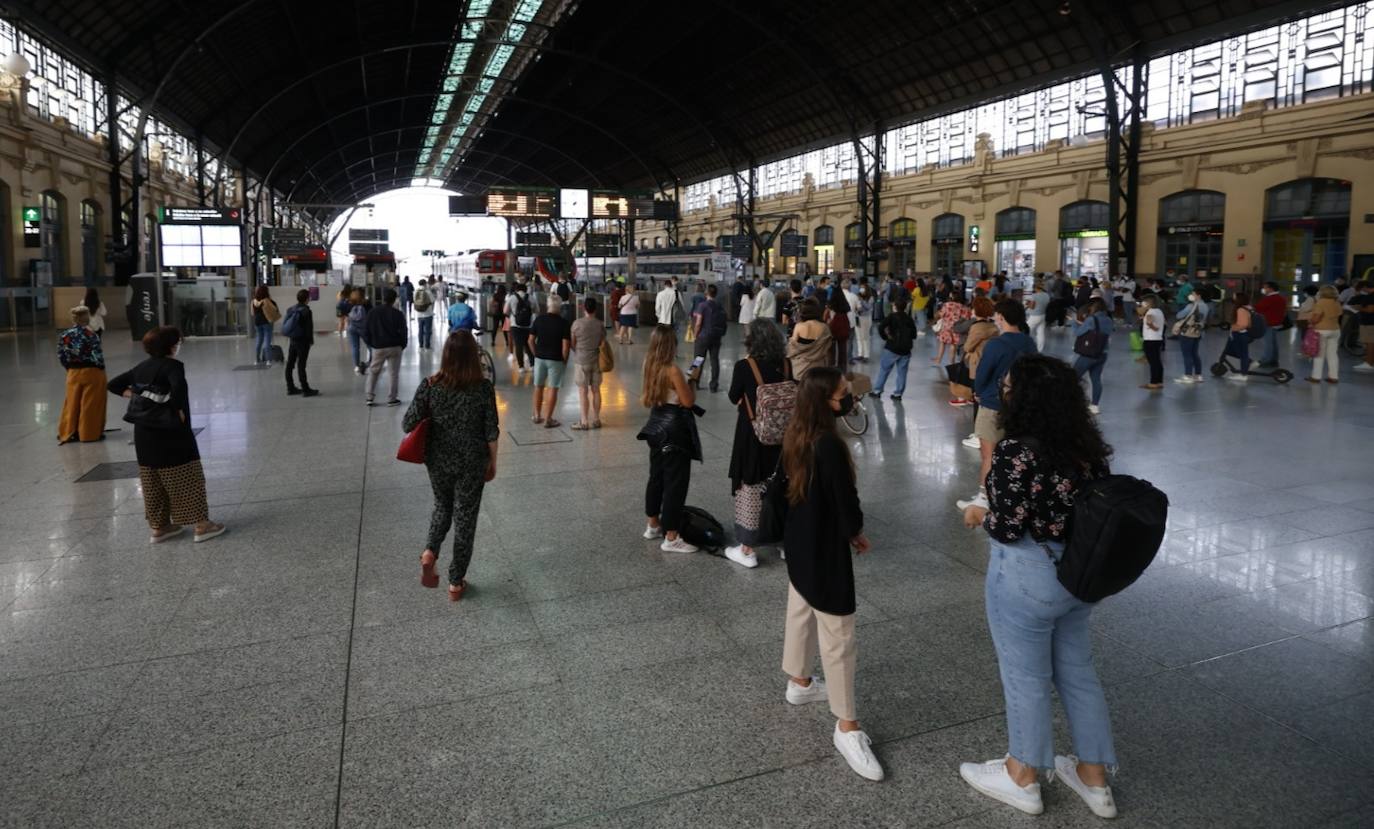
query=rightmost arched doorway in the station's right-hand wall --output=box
[1264,179,1351,286]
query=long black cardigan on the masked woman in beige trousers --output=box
[783,433,863,616]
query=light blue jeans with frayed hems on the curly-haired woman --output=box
[985,538,1116,770]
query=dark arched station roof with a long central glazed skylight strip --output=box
[0,0,1344,217]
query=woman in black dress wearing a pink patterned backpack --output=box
[725,319,791,568]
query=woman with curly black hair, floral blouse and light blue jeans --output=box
[961,355,1117,818]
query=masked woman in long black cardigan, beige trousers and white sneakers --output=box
[782,366,883,781]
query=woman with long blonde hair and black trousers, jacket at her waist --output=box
[638,324,701,553]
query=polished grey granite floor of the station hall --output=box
[0,314,1374,829]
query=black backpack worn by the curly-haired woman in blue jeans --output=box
[1058,474,1169,602]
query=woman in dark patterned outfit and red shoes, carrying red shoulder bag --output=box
[401,330,502,602]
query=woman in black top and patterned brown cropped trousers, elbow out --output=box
[109,326,225,544]
